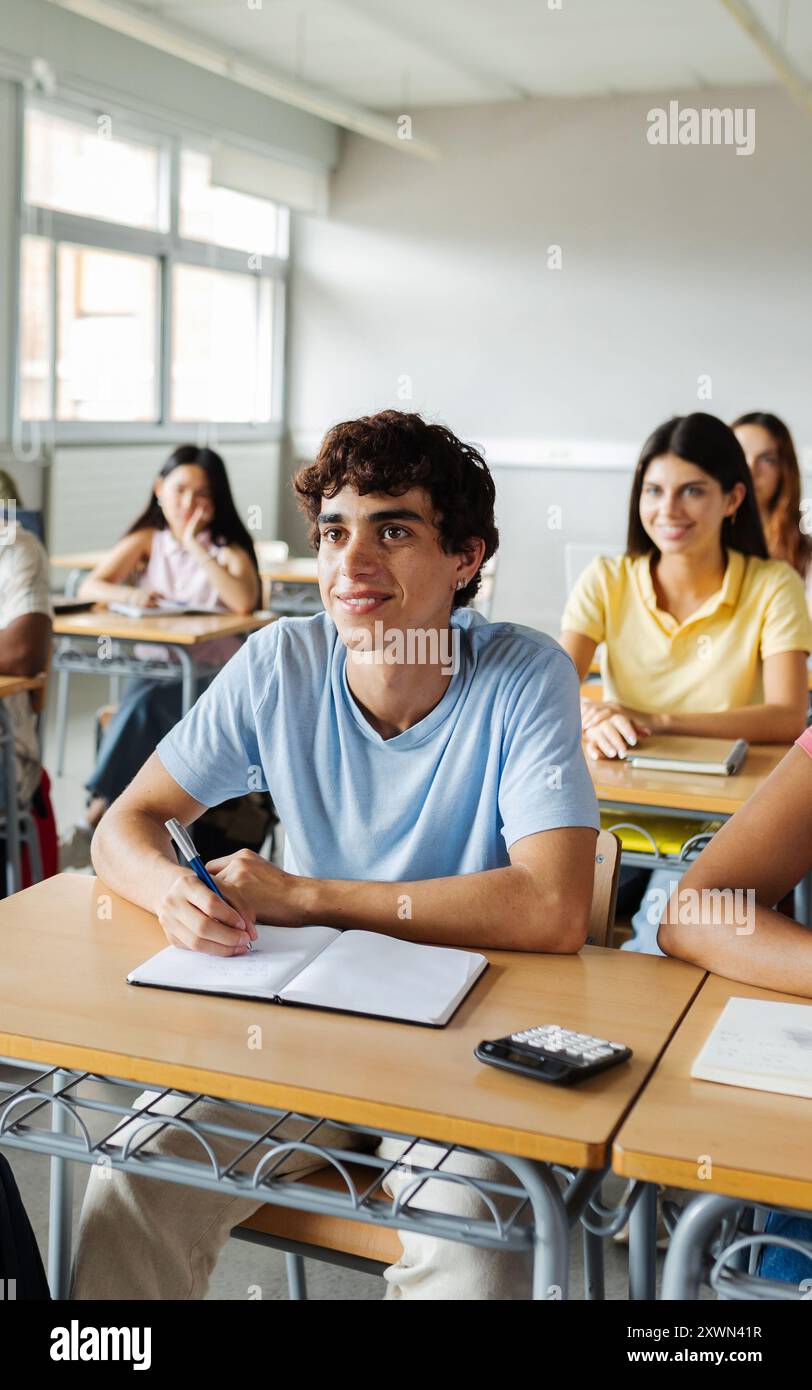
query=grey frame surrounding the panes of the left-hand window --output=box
[11,86,289,448]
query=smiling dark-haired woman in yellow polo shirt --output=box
[560,411,811,954]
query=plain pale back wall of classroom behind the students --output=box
[285,88,812,631]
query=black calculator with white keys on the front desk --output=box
[474,1023,631,1086]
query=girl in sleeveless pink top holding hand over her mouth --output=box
[60,445,260,869]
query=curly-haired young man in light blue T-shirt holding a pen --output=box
[74,410,598,1300]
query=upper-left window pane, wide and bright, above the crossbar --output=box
[25,108,163,231]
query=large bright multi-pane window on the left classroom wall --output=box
[17,99,288,439]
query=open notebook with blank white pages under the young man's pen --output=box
[127,927,488,1027]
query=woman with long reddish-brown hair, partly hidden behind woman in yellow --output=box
[730,410,812,613]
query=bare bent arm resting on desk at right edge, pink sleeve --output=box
[658,748,812,998]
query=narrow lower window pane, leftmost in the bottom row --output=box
[19,236,51,420]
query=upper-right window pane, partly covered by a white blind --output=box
[179,150,278,256]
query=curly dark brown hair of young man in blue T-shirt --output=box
[293,410,499,607]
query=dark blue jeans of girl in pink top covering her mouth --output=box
[85,671,217,802]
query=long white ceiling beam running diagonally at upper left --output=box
[41,0,439,160]
